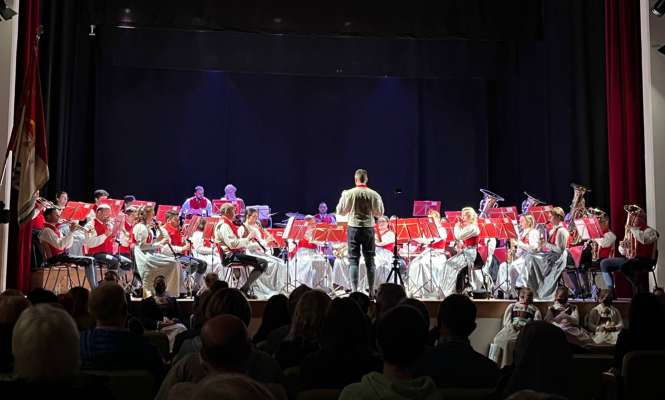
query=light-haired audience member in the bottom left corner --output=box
[0,304,111,400]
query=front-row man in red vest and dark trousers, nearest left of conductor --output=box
[215,203,268,298]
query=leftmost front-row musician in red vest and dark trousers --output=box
[39,208,97,287]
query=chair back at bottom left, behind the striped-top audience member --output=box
[81,370,156,400]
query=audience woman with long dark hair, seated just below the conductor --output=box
[300,298,381,390]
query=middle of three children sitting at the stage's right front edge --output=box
[545,286,592,347]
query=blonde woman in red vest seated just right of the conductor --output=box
[439,207,482,296]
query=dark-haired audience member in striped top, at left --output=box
[81,283,164,382]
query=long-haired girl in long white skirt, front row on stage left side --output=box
[132,206,180,296]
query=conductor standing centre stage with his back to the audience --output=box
[336,169,383,298]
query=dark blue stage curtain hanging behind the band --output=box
[42,0,609,215]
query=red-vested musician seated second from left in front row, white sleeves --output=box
[85,203,131,284]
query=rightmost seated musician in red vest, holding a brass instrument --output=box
[600,206,659,291]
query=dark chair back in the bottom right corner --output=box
[621,351,665,400]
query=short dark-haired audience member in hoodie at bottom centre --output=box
[340,304,439,400]
